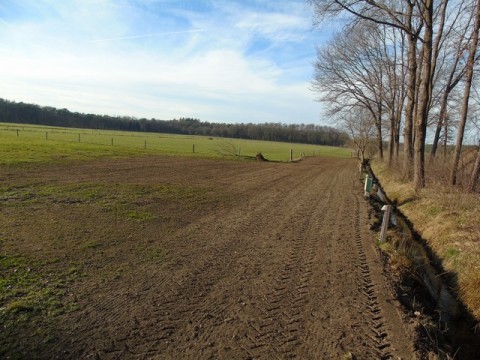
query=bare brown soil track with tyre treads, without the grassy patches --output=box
[16,158,413,359]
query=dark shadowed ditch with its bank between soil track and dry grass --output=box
[366,166,480,360]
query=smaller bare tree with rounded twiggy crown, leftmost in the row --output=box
[312,23,388,159]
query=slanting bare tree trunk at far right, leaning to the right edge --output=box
[450,0,480,186]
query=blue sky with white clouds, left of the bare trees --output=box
[0,0,327,124]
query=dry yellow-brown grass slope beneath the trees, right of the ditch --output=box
[372,156,480,320]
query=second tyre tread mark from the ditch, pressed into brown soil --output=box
[250,171,338,359]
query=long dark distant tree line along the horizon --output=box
[0,99,349,146]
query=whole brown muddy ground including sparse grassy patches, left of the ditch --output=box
[0,157,417,359]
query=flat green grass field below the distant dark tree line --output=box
[0,123,350,165]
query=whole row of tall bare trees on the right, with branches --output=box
[309,0,480,190]
